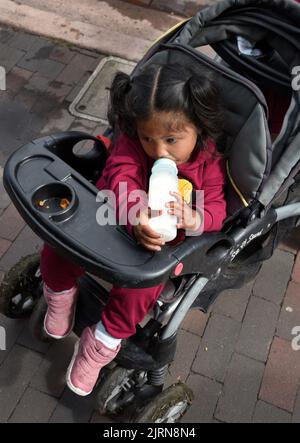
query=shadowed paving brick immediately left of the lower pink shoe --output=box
[31,334,77,398]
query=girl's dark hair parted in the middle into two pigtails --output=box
[108,64,223,151]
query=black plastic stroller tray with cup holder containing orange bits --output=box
[4,132,231,287]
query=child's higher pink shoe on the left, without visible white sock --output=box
[44,284,78,340]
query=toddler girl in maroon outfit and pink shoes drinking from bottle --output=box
[41,64,226,395]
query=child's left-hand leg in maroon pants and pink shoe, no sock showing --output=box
[40,245,84,339]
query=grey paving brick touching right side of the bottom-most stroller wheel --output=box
[180,374,222,423]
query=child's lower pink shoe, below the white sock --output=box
[67,327,121,396]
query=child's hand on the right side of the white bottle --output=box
[166,192,201,231]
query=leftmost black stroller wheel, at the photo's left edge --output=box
[0,254,41,318]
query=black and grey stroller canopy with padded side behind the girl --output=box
[133,0,300,215]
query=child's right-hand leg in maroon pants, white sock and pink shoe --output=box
[67,285,164,396]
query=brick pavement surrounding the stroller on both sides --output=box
[0,23,300,423]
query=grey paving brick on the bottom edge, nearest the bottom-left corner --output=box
[8,388,57,423]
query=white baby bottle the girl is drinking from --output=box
[148,158,178,242]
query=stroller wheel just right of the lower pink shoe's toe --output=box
[97,366,142,415]
